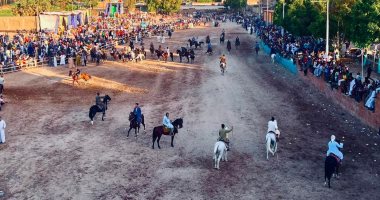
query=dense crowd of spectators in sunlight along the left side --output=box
[0,12,200,73]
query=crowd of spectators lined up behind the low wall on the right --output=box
[235,16,380,112]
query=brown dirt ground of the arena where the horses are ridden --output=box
[0,23,380,199]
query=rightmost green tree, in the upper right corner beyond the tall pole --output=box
[345,0,380,48]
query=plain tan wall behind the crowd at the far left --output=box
[0,16,36,32]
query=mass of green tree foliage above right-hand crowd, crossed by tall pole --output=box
[273,0,380,47]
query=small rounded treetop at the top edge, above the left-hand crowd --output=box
[146,0,182,13]
